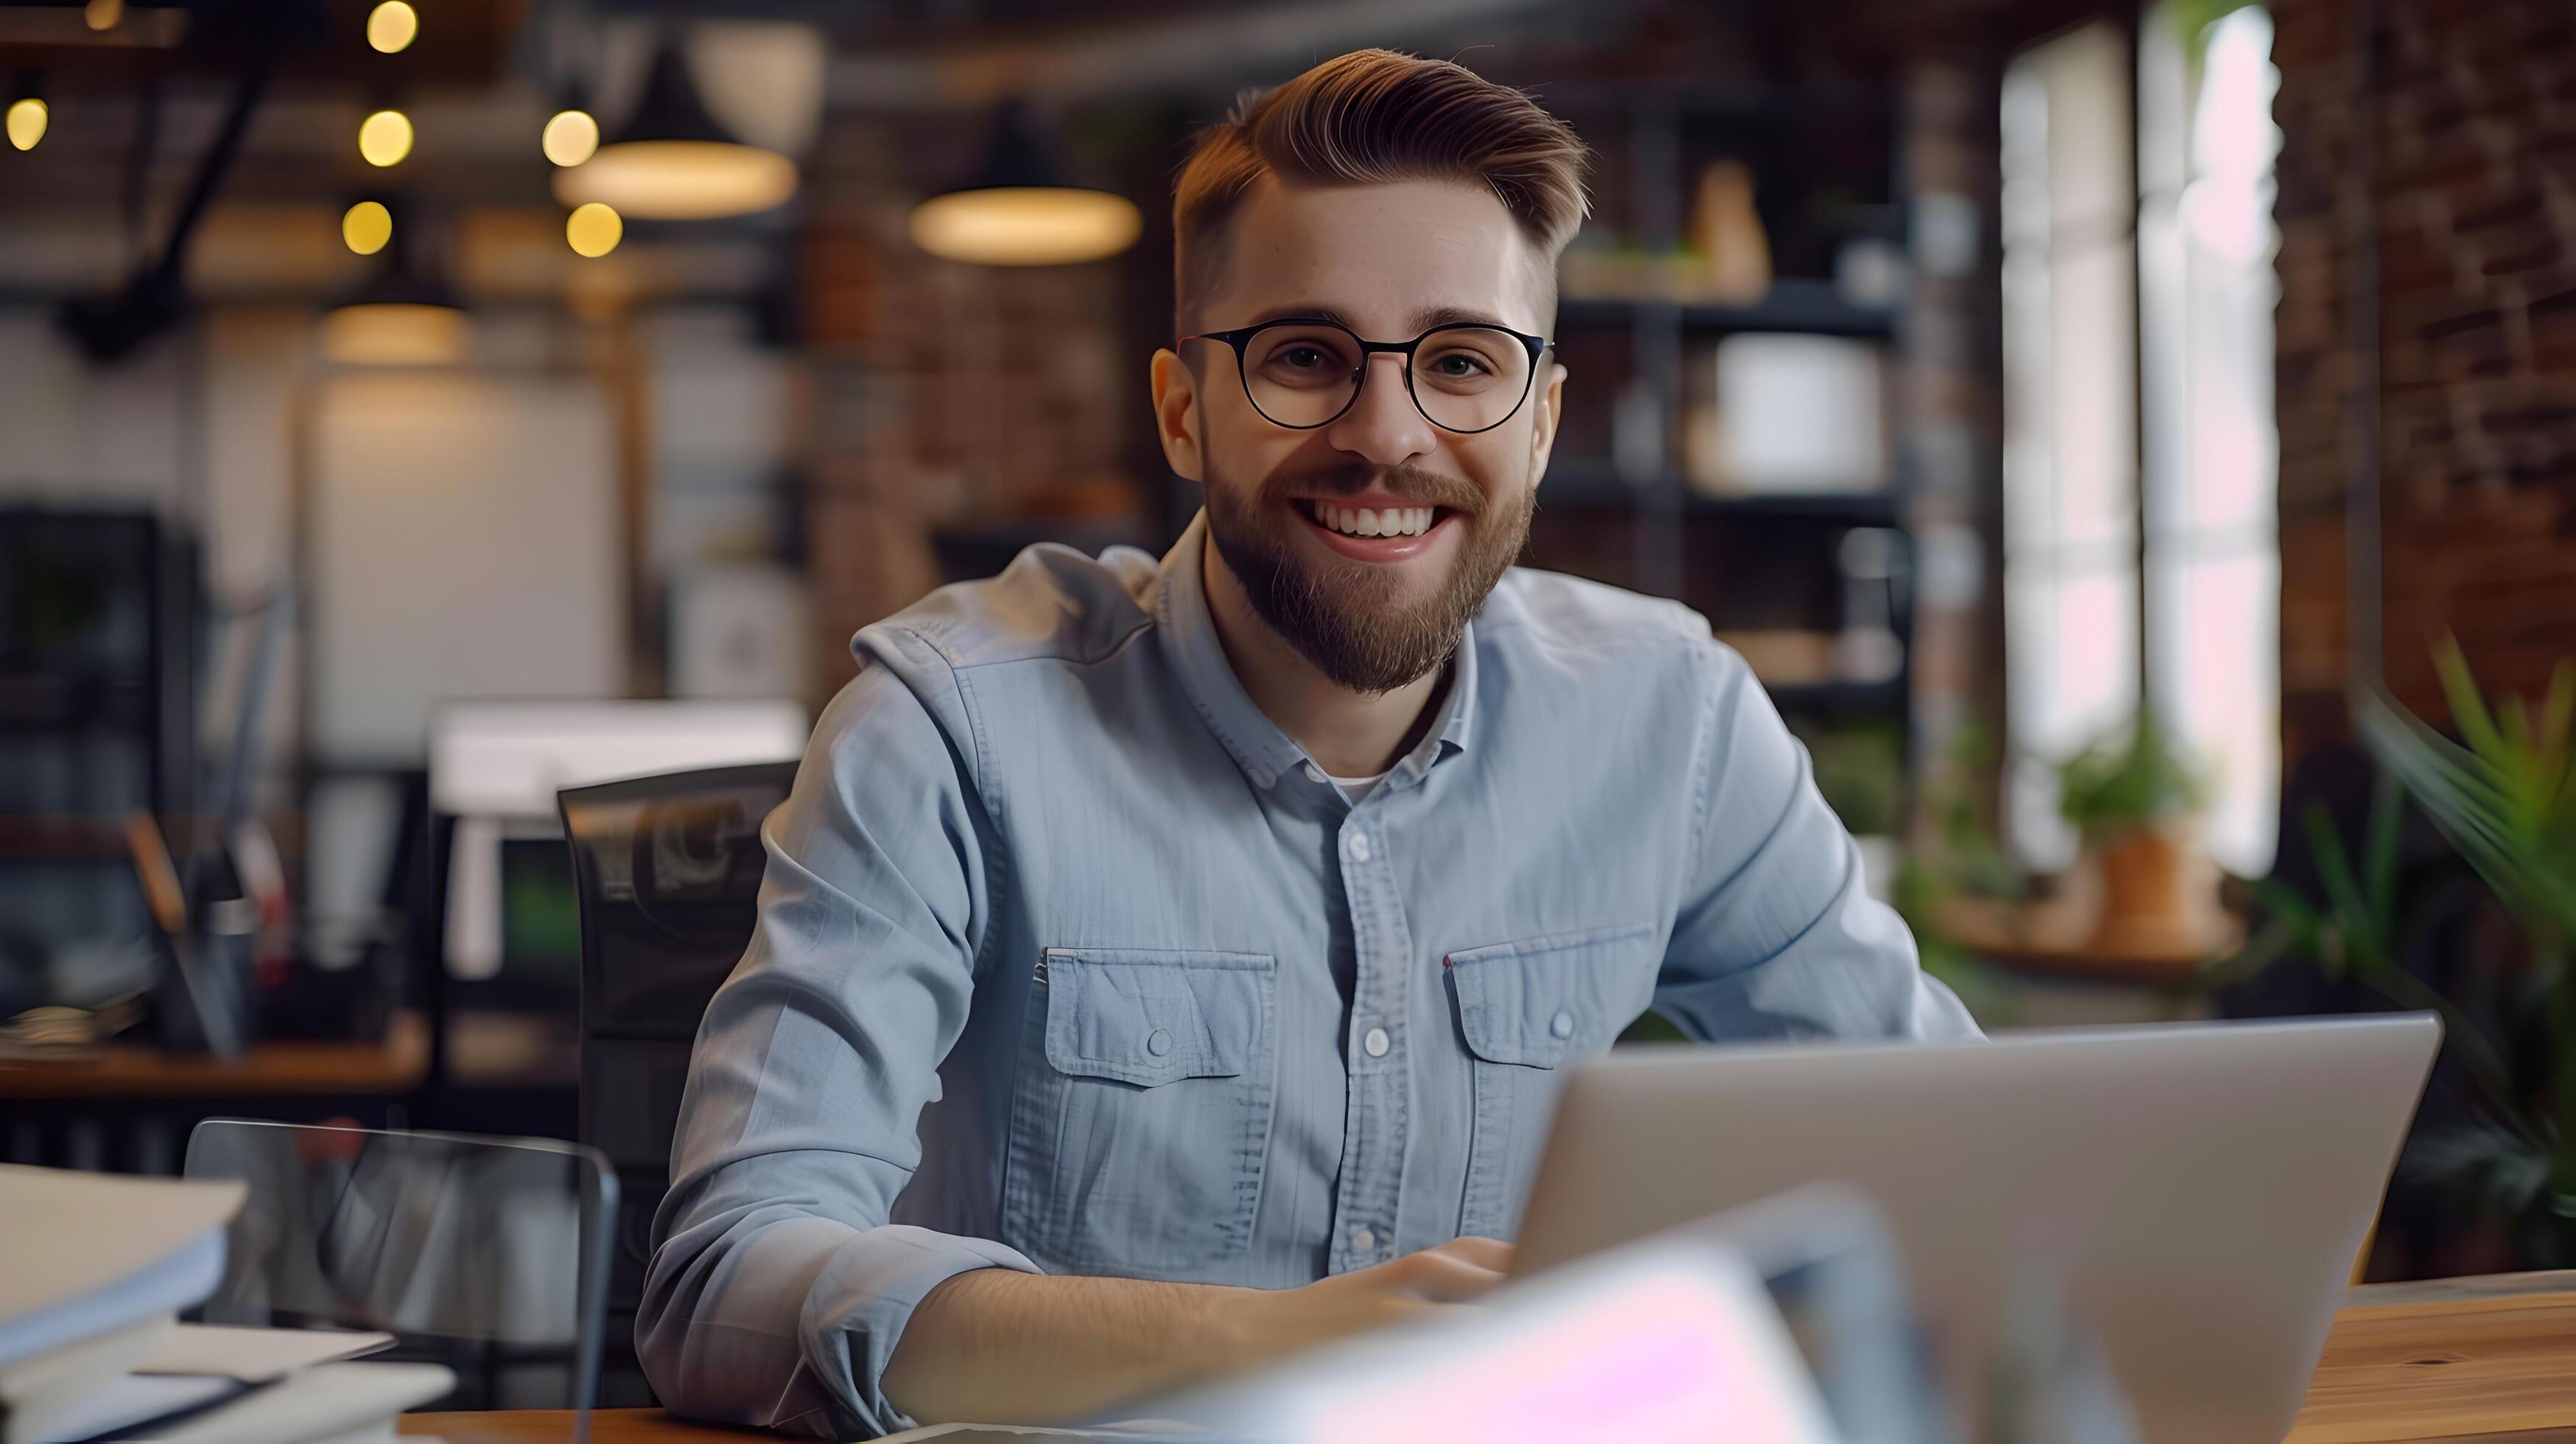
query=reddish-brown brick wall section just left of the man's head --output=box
[799,116,1144,694]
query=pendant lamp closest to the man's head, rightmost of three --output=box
[912,101,1144,266]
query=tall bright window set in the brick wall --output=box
[2001,5,2280,875]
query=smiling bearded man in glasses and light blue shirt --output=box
[636,52,1973,1434]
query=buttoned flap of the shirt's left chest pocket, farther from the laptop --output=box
[1025,949,1278,1088]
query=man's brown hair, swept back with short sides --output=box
[1172,49,1592,328]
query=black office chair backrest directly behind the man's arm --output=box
[556,763,796,1406]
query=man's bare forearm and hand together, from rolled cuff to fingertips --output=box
[883,1238,1512,1423]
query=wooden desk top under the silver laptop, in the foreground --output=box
[402,1272,2576,1444]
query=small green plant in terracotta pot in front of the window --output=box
[2058,712,2225,959]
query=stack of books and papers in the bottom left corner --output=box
[0,1166,456,1444]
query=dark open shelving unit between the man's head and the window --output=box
[1533,85,1912,758]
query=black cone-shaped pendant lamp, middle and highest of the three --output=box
[554,39,796,222]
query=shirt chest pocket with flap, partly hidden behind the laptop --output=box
[1442,923,1657,1238]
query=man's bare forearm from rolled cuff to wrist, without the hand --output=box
[883,1269,1260,1423]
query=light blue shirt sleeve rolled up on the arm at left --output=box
[636,652,1036,1439]
